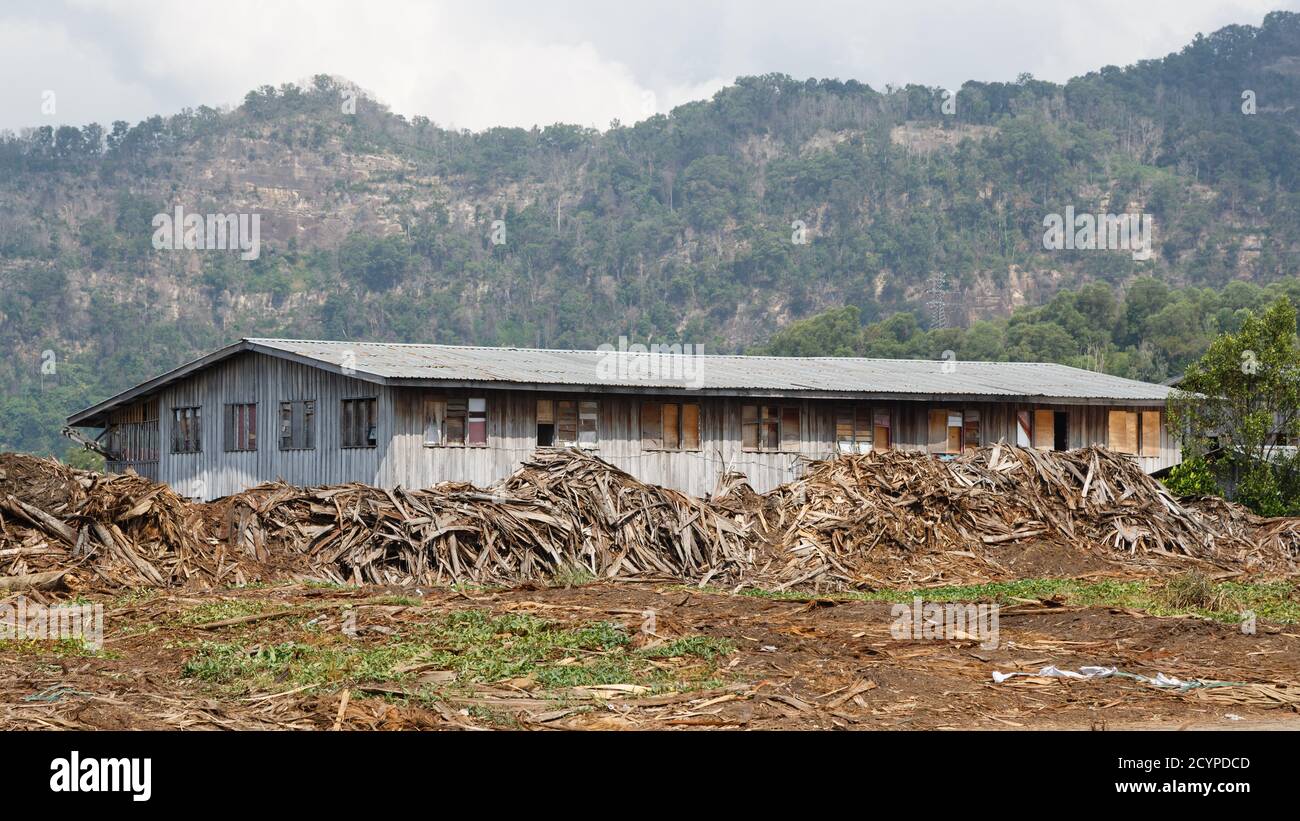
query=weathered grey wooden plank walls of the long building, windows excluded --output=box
[109,353,1178,499]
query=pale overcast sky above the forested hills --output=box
[0,0,1300,130]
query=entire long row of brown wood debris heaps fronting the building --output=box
[0,444,1300,590]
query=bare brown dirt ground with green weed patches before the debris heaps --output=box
[0,583,1300,730]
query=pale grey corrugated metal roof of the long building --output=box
[247,339,1170,401]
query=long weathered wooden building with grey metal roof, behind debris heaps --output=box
[68,339,1179,499]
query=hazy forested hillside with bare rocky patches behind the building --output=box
[0,13,1300,452]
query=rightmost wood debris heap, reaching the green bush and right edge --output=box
[754,444,1300,586]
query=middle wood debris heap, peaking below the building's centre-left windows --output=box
[224,451,750,585]
